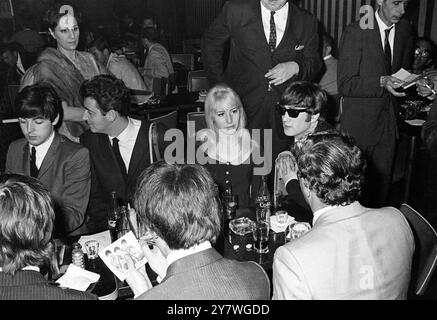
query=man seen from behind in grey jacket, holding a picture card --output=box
[126,162,270,300]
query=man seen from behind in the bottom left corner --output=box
[0,174,97,300]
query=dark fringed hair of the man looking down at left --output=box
[15,83,63,124]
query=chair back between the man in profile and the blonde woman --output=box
[149,110,178,163]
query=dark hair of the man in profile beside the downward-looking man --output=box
[80,74,130,116]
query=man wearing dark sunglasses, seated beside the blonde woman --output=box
[275,81,334,223]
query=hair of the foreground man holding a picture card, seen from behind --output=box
[134,161,221,250]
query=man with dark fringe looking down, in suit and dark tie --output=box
[6,84,91,237]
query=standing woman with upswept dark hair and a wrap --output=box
[20,5,108,142]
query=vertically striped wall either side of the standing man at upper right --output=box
[300,0,437,48]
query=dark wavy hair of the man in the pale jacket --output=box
[292,132,366,205]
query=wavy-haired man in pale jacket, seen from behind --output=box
[273,134,414,300]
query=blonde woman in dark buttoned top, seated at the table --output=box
[196,84,259,212]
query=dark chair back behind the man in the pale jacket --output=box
[400,203,437,296]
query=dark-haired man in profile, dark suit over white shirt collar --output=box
[80,75,150,233]
